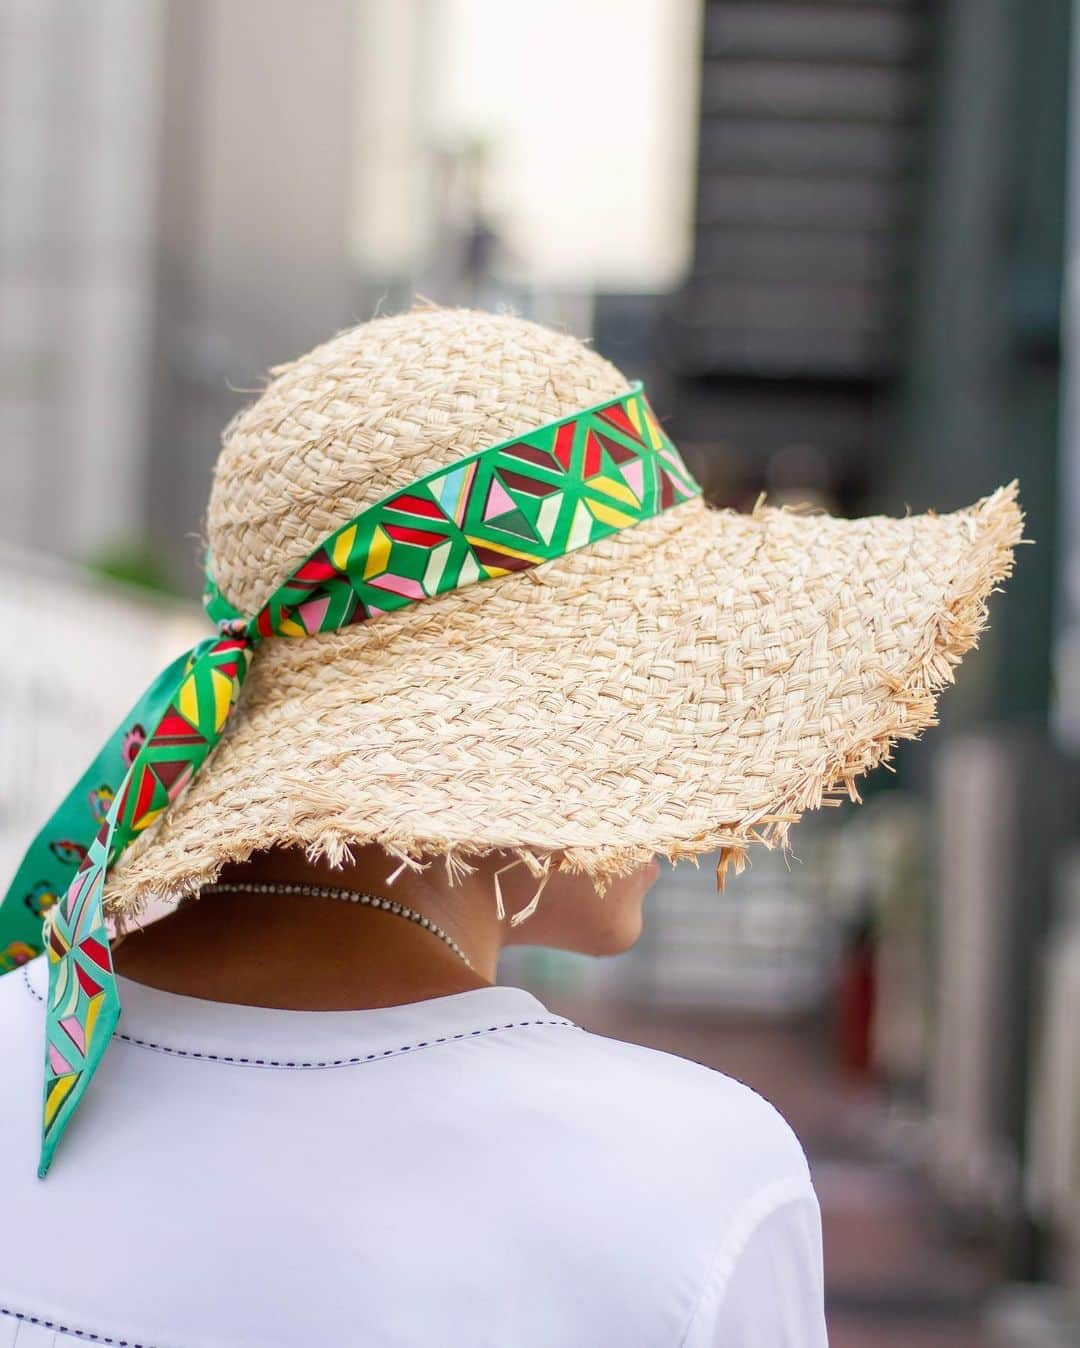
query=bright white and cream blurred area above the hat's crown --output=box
[353,0,702,293]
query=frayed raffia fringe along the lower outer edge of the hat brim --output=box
[105,481,1025,925]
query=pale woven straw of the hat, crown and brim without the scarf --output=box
[108,310,1022,913]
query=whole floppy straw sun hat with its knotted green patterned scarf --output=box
[0,310,1021,1174]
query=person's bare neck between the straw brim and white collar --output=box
[115,848,502,1011]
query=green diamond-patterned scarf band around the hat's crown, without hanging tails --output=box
[208,388,700,636]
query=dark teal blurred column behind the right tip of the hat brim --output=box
[890,0,1057,733]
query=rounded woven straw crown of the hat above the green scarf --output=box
[208,310,630,612]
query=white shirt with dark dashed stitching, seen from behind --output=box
[0,960,825,1348]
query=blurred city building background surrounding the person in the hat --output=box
[0,0,1080,1348]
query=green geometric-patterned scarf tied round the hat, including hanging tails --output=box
[0,384,700,1175]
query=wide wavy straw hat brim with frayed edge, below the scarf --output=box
[107,485,1022,914]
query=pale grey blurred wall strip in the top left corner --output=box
[0,0,164,553]
